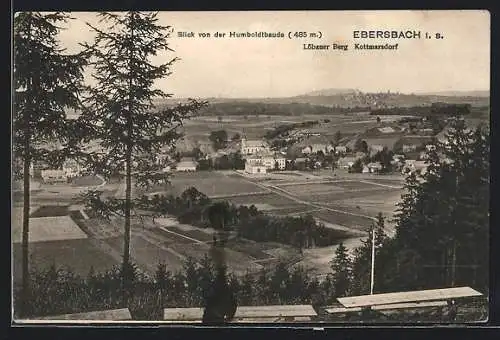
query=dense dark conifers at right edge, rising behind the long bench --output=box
[368,121,490,291]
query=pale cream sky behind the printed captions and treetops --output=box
[56,10,490,98]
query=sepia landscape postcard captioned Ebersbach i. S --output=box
[11,10,494,327]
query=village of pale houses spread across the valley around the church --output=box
[31,113,456,184]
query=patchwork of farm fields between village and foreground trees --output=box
[13,167,402,282]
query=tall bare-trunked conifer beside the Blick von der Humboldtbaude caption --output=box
[79,12,205,291]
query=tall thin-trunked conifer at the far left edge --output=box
[13,12,85,315]
